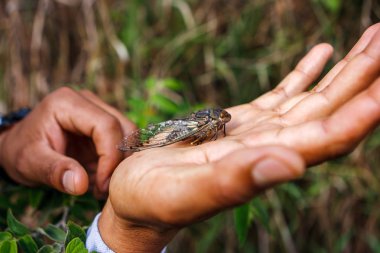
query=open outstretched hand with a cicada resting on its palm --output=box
[99,24,380,252]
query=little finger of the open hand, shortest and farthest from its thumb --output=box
[252,43,333,110]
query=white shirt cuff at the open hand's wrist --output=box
[86,213,166,253]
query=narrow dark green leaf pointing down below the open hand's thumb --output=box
[234,203,250,246]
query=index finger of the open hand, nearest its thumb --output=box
[272,78,380,164]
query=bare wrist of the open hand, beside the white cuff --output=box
[98,201,178,253]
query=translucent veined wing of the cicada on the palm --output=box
[119,118,211,151]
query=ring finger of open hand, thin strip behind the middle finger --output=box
[313,23,380,92]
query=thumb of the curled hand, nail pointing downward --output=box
[29,143,89,195]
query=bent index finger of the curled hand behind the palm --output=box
[43,88,123,192]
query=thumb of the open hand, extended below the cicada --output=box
[212,146,305,208]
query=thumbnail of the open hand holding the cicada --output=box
[252,158,299,188]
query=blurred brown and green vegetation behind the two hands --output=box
[0,0,380,253]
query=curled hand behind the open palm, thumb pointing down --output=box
[0,87,134,197]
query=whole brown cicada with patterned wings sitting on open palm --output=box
[119,108,231,151]
